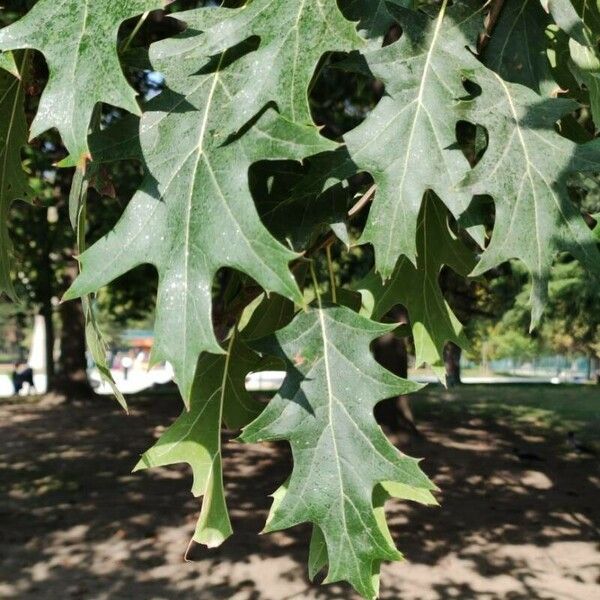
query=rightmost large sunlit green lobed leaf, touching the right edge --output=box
[463,70,600,324]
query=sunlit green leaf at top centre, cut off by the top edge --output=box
[188,0,363,130]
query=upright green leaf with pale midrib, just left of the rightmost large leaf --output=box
[345,2,481,279]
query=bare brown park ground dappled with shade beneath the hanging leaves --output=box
[0,386,600,600]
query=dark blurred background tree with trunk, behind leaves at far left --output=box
[0,0,162,395]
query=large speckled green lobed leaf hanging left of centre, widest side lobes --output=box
[66,11,333,404]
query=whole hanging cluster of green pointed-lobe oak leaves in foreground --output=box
[0,0,600,598]
